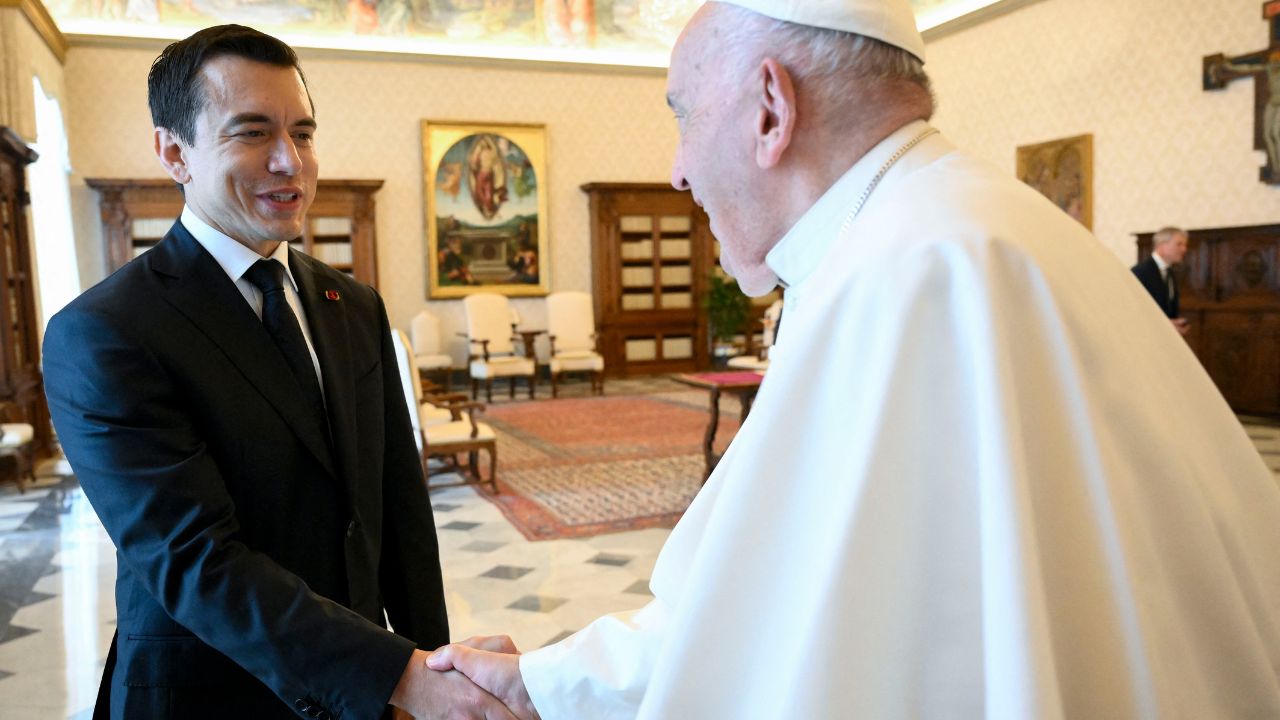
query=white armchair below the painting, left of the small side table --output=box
[462,292,538,402]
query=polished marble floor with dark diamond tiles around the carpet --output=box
[0,404,1280,720]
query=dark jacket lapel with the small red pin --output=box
[289,249,358,504]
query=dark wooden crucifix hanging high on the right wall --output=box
[1203,0,1280,184]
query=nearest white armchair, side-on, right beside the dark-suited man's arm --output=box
[392,329,498,493]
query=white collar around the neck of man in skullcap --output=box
[764,120,929,287]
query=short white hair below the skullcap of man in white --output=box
[716,3,934,115]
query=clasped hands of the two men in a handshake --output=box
[390,635,538,720]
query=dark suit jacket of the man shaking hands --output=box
[45,223,448,720]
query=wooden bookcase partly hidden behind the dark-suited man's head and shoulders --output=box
[84,178,383,287]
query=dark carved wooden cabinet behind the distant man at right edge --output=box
[1138,224,1280,416]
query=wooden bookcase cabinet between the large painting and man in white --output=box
[582,183,778,375]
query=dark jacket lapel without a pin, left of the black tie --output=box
[146,223,338,477]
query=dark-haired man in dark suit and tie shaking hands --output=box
[45,26,509,720]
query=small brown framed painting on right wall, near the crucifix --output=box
[1018,135,1093,229]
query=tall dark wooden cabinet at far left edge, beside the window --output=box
[0,128,52,457]
